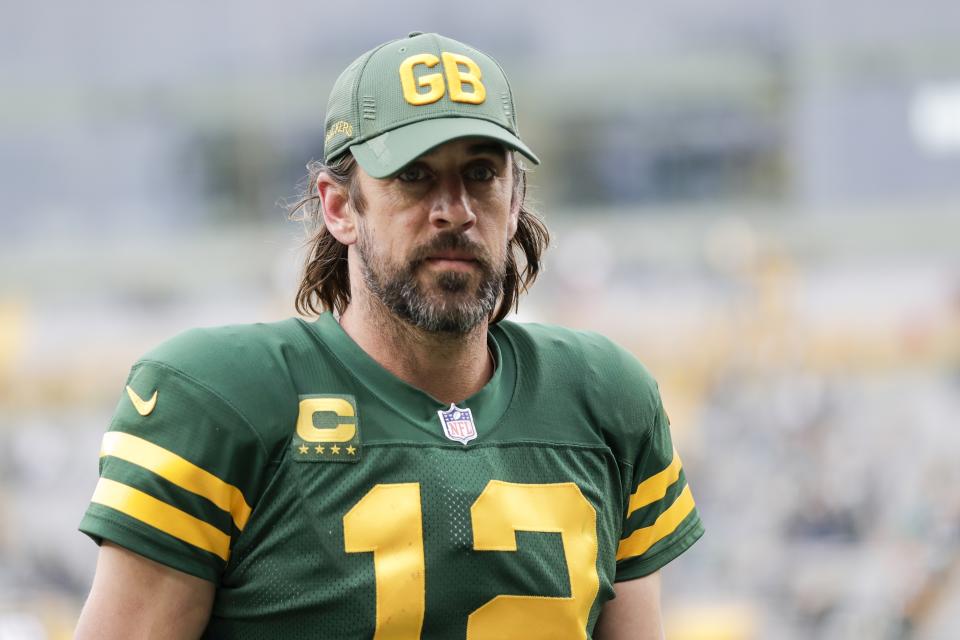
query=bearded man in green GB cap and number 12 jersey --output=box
[77,33,702,639]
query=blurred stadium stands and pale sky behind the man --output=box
[0,0,960,640]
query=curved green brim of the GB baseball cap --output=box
[350,118,540,178]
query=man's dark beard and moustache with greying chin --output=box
[357,226,506,335]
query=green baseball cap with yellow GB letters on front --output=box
[323,32,540,178]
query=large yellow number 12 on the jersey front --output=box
[343,480,599,640]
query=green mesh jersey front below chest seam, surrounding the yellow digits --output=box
[208,445,621,638]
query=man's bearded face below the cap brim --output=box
[357,138,518,334]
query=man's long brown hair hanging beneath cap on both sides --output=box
[289,153,550,323]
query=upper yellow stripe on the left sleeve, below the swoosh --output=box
[100,431,250,531]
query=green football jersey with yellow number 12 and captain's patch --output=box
[80,314,703,640]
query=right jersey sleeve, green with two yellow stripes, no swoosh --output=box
[615,383,703,582]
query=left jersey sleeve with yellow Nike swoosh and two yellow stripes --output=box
[80,361,268,582]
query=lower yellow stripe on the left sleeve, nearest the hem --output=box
[91,478,230,561]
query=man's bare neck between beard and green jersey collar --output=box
[340,297,494,404]
